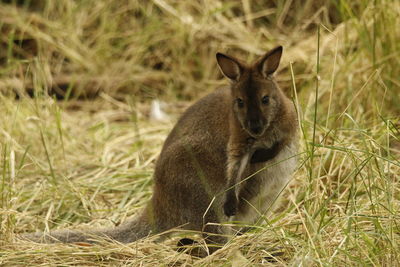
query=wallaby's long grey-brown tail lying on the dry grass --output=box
[22,211,154,246]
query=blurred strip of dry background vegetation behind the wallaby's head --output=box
[0,0,400,111]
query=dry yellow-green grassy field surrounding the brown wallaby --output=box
[0,0,400,266]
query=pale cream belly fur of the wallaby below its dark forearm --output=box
[232,141,297,224]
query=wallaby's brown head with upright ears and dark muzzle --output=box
[217,46,283,138]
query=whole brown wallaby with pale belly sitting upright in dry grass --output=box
[22,46,298,258]
